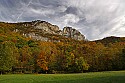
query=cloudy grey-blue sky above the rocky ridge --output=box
[0,0,125,40]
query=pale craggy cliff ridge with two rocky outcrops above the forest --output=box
[15,20,85,41]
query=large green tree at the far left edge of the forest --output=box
[0,41,18,74]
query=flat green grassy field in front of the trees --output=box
[0,71,125,83]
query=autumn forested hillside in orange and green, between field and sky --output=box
[0,22,125,74]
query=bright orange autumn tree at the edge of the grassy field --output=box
[37,42,57,71]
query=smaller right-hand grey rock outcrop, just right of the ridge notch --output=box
[63,27,85,40]
